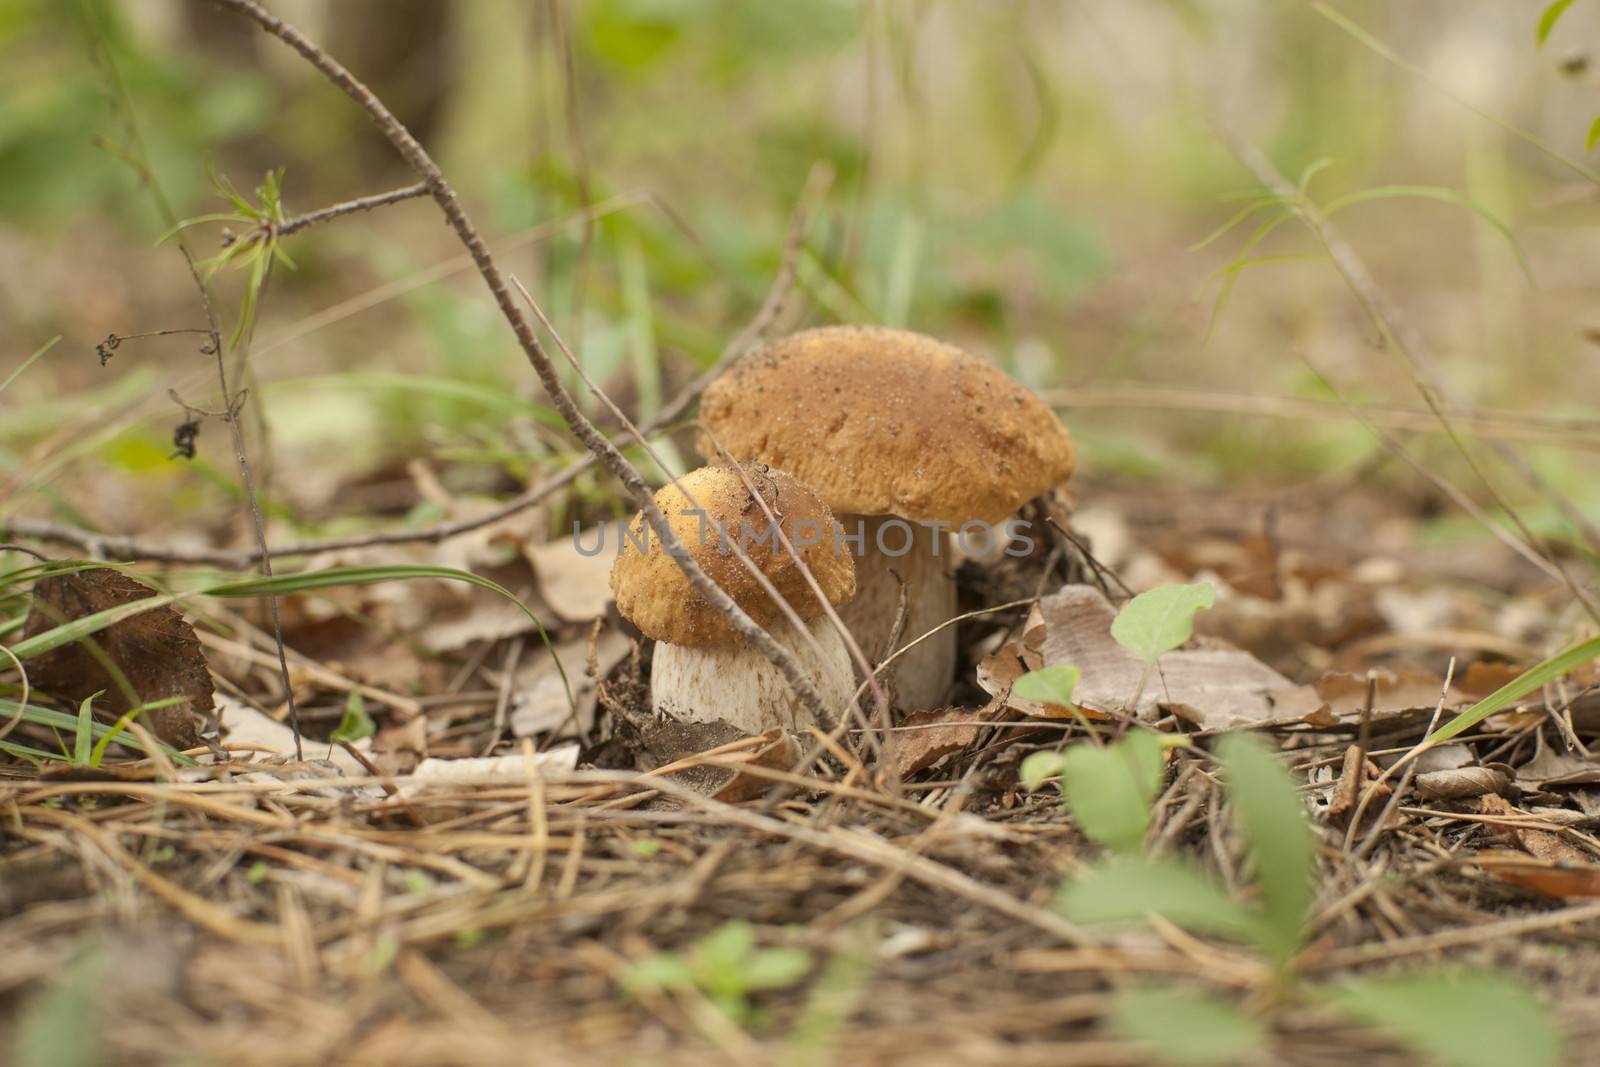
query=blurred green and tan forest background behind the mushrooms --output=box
[0,0,1600,547]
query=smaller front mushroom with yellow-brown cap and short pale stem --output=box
[611,466,856,734]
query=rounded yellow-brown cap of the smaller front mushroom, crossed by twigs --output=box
[611,464,856,648]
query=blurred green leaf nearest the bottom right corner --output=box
[1328,969,1563,1067]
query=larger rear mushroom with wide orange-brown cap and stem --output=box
[701,326,1074,709]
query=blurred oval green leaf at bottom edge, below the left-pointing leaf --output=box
[1107,985,1267,1067]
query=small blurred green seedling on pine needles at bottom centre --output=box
[622,920,811,1025]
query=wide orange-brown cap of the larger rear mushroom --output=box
[701,326,1072,523]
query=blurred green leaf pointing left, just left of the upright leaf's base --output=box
[1058,856,1261,941]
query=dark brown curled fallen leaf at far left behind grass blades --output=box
[22,568,214,749]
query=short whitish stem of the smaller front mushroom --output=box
[650,616,856,736]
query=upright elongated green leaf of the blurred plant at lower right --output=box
[1218,734,1317,963]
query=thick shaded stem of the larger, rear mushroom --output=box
[838,515,960,710]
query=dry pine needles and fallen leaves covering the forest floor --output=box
[0,486,1600,1064]
